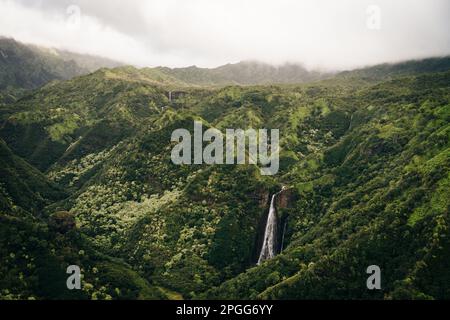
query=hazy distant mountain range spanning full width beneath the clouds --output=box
[0,37,450,90]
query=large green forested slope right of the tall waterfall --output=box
[204,73,450,299]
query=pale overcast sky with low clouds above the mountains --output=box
[0,0,450,69]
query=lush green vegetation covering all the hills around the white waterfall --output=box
[0,43,450,299]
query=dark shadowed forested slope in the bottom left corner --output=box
[0,140,166,299]
